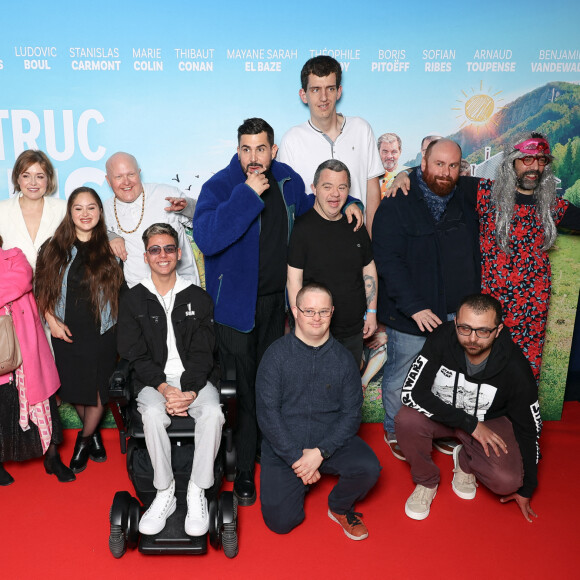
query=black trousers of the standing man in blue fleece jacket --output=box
[216,292,285,471]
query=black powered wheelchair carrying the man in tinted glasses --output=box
[109,360,238,558]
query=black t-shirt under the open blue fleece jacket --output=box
[258,170,288,296]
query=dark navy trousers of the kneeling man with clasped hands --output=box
[260,436,381,534]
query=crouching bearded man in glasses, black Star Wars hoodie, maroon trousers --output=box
[395,294,542,521]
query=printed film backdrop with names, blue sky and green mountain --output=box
[0,0,580,418]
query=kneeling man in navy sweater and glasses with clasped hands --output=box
[256,283,381,540]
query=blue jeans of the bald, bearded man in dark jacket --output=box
[382,326,425,433]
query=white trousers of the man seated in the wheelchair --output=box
[137,382,224,489]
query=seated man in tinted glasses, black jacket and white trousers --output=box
[117,223,224,536]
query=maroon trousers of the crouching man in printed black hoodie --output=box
[395,406,524,495]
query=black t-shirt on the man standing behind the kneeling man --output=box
[288,208,373,338]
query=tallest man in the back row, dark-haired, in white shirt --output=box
[278,56,385,233]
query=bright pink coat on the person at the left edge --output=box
[0,248,60,405]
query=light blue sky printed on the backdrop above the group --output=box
[0,0,580,199]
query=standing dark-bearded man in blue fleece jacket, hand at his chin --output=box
[193,118,362,506]
